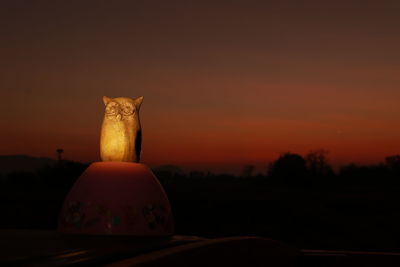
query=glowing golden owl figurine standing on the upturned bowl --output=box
[100,96,143,162]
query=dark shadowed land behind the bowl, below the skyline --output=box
[0,156,400,266]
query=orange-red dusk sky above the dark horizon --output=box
[0,0,400,174]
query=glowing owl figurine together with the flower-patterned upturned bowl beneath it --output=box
[58,97,173,236]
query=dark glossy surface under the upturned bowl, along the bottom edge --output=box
[0,229,400,267]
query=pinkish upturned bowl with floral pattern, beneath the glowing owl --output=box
[58,162,174,236]
